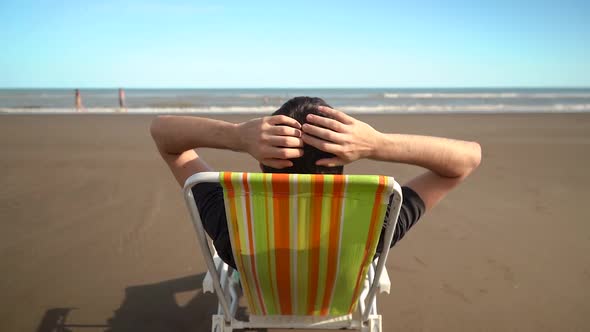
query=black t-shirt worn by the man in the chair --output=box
[193,183,425,268]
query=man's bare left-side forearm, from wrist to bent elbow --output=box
[150,115,241,154]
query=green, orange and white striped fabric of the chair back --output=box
[220,172,392,316]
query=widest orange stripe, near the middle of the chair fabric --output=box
[272,173,292,315]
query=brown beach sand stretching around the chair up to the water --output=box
[0,114,590,332]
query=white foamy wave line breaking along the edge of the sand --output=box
[0,103,590,114]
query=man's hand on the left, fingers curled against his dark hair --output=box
[237,115,303,169]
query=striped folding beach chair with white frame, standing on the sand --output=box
[184,172,402,332]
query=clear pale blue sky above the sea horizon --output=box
[0,0,590,88]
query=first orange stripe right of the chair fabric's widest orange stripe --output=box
[307,174,324,315]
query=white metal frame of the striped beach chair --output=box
[183,172,403,332]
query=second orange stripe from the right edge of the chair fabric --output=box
[320,175,344,316]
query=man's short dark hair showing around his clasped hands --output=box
[262,97,344,174]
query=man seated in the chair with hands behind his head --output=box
[151,97,481,267]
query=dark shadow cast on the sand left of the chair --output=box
[37,273,217,332]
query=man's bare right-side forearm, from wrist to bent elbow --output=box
[370,134,481,178]
